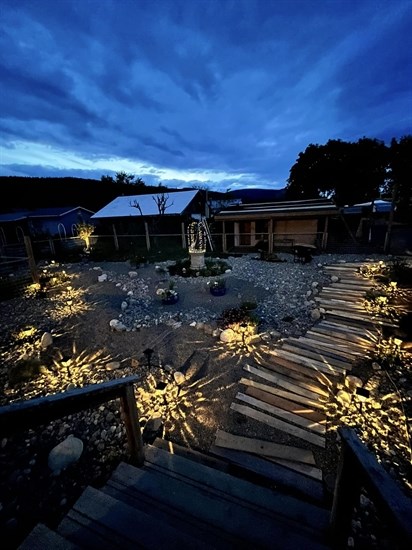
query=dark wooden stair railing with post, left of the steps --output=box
[0,376,144,466]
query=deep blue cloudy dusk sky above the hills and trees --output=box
[0,0,412,190]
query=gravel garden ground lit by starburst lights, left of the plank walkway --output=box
[0,255,408,548]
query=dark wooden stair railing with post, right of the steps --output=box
[330,427,412,548]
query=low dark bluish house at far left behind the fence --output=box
[0,206,93,245]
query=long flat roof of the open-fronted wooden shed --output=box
[215,199,338,221]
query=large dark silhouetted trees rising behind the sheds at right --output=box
[286,135,412,216]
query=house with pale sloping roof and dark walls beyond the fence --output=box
[91,189,205,235]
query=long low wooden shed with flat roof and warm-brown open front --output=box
[214,199,339,253]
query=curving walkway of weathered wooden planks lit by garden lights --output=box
[212,263,393,479]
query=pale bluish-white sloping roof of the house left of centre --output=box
[91,189,199,220]
